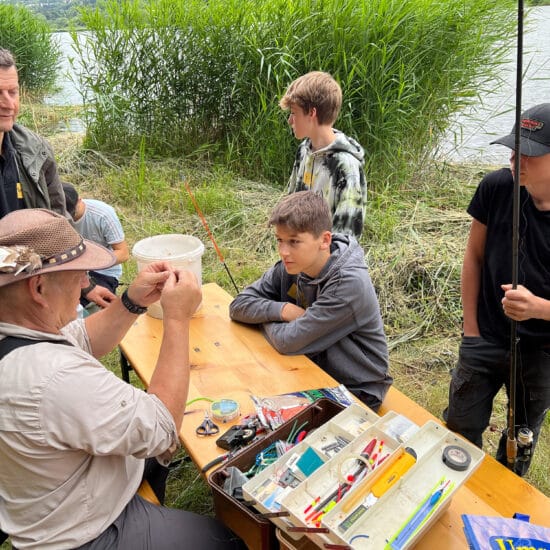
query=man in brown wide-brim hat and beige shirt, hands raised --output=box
[0,209,246,550]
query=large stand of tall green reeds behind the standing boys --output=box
[74,0,515,189]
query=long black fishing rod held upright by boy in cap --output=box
[506,0,523,471]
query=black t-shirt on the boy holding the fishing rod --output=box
[468,168,550,347]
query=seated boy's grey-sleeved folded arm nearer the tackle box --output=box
[263,276,381,355]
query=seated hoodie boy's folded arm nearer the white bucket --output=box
[229,262,286,325]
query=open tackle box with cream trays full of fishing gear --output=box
[209,400,484,550]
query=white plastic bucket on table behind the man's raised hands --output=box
[132,233,204,319]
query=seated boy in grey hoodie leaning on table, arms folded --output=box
[229,191,393,411]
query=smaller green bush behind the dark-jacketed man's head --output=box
[0,4,60,95]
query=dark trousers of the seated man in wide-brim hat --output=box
[76,459,246,550]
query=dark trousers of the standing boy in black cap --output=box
[443,336,550,475]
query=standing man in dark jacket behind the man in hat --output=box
[0,48,67,218]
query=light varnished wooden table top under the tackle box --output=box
[120,283,550,549]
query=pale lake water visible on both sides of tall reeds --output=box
[46,6,550,164]
